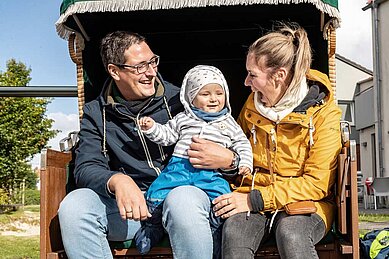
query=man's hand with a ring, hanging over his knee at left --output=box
[108,173,151,221]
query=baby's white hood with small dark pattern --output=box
[180,65,231,117]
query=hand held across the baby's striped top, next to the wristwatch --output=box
[188,137,233,169]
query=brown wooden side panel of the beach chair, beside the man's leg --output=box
[40,149,72,259]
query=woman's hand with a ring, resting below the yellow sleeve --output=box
[212,192,251,219]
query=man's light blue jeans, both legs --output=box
[58,186,213,259]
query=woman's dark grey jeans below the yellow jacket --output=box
[222,212,326,259]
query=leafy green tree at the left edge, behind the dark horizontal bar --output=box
[0,59,57,199]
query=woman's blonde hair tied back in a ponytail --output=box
[248,23,312,90]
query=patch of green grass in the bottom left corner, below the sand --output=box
[0,235,39,259]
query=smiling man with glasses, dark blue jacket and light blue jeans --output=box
[58,31,234,259]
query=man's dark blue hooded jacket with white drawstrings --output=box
[74,74,183,197]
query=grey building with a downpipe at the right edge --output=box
[355,0,389,179]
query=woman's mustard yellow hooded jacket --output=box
[237,70,342,231]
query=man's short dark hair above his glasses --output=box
[100,31,146,72]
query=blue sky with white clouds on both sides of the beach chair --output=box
[0,0,373,167]
